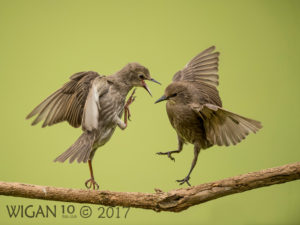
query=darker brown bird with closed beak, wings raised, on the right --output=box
[155,46,262,186]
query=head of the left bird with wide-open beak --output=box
[126,63,160,96]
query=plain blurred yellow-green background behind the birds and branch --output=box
[0,0,300,224]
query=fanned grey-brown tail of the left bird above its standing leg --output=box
[54,132,95,163]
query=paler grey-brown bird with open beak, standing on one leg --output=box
[26,63,159,189]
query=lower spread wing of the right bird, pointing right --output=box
[191,104,262,146]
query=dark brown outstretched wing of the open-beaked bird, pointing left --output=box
[26,71,100,127]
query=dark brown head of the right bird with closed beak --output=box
[155,82,191,103]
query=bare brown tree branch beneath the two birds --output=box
[0,162,300,212]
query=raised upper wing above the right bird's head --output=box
[173,46,220,87]
